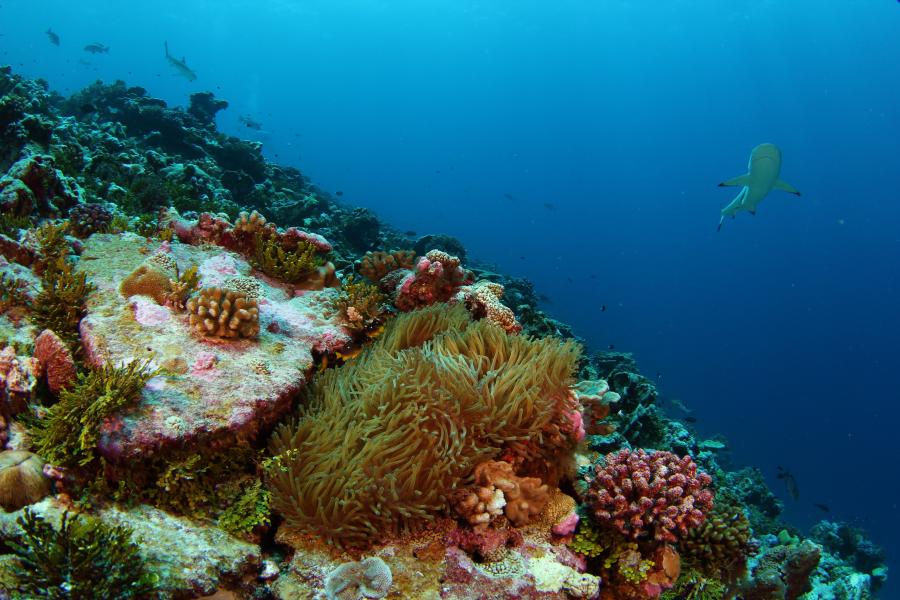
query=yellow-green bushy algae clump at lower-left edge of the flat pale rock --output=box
[31,360,155,466]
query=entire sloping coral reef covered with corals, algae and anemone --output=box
[0,68,886,600]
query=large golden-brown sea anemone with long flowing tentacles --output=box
[268,307,579,546]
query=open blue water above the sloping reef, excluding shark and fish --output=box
[0,0,900,597]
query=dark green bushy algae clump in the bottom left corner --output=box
[8,509,154,600]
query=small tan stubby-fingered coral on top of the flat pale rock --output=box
[187,287,259,338]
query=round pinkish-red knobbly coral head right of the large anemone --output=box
[588,449,713,542]
